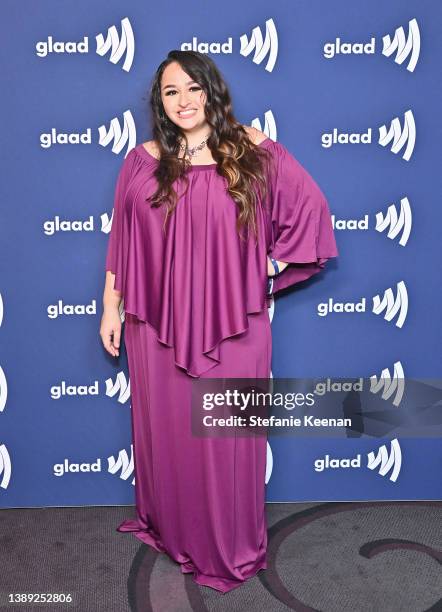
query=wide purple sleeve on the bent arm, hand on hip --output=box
[267,142,338,293]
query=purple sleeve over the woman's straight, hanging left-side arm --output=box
[105,149,136,297]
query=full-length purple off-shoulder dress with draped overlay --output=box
[106,138,338,592]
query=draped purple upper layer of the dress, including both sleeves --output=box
[106,138,337,377]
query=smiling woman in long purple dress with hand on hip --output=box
[100,51,337,592]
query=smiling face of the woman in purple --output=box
[161,62,207,132]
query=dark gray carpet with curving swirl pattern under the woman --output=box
[0,501,442,612]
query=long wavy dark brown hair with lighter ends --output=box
[146,50,270,237]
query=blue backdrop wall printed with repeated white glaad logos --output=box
[0,0,442,507]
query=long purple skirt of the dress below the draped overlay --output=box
[118,310,272,592]
